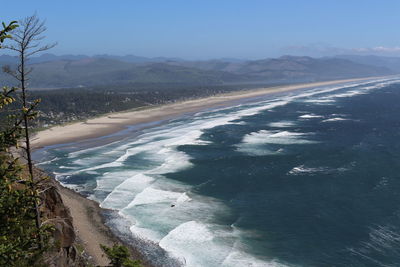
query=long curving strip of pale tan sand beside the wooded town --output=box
[31,77,384,149]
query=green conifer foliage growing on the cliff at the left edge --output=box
[0,19,51,267]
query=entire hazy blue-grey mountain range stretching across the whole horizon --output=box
[0,54,400,88]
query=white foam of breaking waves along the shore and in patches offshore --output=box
[41,77,400,266]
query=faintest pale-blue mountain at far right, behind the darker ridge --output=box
[335,55,400,73]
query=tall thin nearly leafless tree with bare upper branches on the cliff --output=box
[3,14,56,249]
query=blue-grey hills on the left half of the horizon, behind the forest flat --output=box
[0,58,247,88]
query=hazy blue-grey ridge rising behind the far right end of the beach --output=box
[169,56,393,81]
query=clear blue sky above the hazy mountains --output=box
[0,0,400,59]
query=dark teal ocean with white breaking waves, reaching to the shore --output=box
[34,78,400,267]
